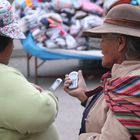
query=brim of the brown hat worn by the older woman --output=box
[83,23,140,38]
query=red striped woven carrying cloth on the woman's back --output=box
[103,76,140,140]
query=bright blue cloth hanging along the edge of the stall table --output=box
[21,33,101,60]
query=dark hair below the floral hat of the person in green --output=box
[0,35,13,52]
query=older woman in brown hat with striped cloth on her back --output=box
[64,4,140,140]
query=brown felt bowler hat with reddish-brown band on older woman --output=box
[83,4,140,38]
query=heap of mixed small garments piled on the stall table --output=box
[15,0,104,50]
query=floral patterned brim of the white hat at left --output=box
[0,22,26,39]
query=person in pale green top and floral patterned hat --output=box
[0,0,59,140]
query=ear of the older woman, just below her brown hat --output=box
[118,35,127,53]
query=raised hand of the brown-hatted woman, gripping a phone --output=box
[64,70,87,102]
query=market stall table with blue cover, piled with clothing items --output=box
[15,0,138,82]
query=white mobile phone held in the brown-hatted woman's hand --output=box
[69,71,78,89]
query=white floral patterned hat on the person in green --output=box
[0,0,25,39]
